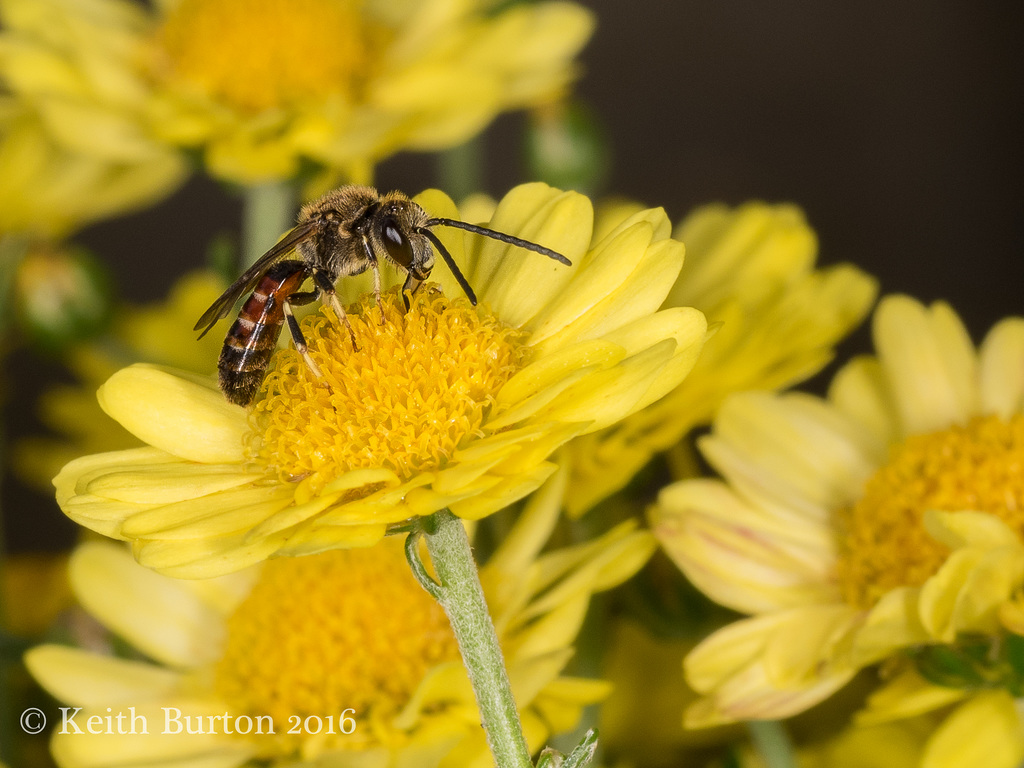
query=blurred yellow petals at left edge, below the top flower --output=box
[0,97,184,240]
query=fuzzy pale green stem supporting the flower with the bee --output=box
[407,509,532,768]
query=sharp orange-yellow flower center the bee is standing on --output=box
[249,288,524,487]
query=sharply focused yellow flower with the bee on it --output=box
[54,184,706,577]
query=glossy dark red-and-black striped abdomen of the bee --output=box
[217,261,308,406]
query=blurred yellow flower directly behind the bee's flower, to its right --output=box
[568,203,876,515]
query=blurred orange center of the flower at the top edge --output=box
[159,0,367,112]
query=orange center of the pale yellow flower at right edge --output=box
[839,415,1024,608]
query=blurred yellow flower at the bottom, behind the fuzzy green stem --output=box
[26,473,654,768]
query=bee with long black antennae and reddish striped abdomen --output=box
[194,185,571,406]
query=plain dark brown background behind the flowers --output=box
[3,0,1024,549]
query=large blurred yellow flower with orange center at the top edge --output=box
[0,0,593,184]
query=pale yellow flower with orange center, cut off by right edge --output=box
[652,297,1024,726]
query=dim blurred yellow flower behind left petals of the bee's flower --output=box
[13,271,225,488]
